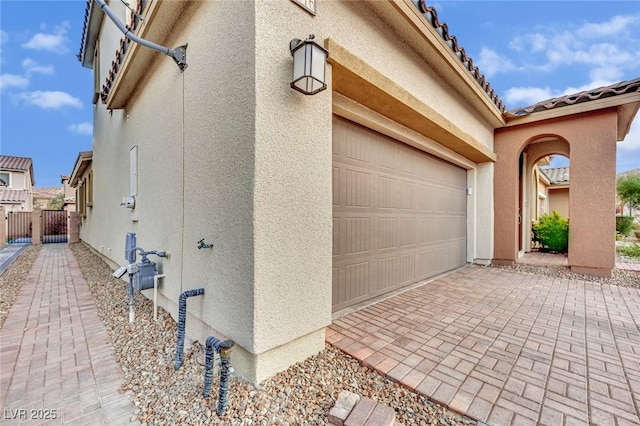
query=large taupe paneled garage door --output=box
[333,116,467,311]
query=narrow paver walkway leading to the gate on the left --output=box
[0,244,135,425]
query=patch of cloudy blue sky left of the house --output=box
[0,0,93,187]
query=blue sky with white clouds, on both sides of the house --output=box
[0,0,640,187]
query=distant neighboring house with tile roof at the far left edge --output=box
[0,155,35,212]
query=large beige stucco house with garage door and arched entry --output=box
[79,0,640,383]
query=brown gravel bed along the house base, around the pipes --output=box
[70,244,475,425]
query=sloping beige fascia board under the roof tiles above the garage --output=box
[388,0,505,126]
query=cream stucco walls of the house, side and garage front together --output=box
[81,2,493,382]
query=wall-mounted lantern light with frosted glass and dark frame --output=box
[289,34,329,95]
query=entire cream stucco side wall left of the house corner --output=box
[82,2,254,350]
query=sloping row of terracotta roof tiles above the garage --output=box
[412,0,506,112]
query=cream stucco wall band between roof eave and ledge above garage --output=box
[318,1,493,149]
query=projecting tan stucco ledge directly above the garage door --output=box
[324,38,496,163]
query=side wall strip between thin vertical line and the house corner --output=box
[179,2,256,353]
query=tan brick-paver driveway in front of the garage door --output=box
[327,266,640,426]
